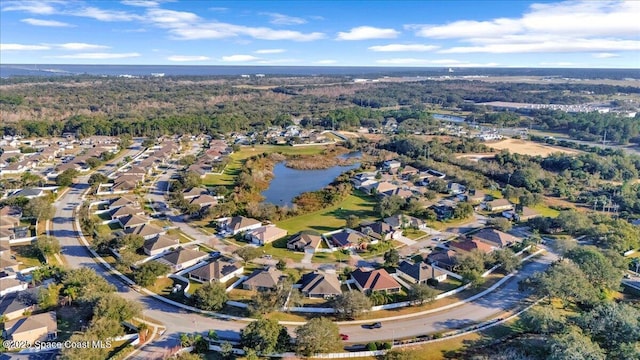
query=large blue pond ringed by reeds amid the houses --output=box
[262,162,360,206]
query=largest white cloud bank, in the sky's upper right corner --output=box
[405,0,640,53]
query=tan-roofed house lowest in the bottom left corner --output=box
[2,311,58,344]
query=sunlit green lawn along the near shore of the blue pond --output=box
[277,190,378,234]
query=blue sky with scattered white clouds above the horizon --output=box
[0,0,640,68]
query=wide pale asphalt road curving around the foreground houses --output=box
[51,145,554,359]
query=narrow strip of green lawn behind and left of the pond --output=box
[203,145,325,186]
